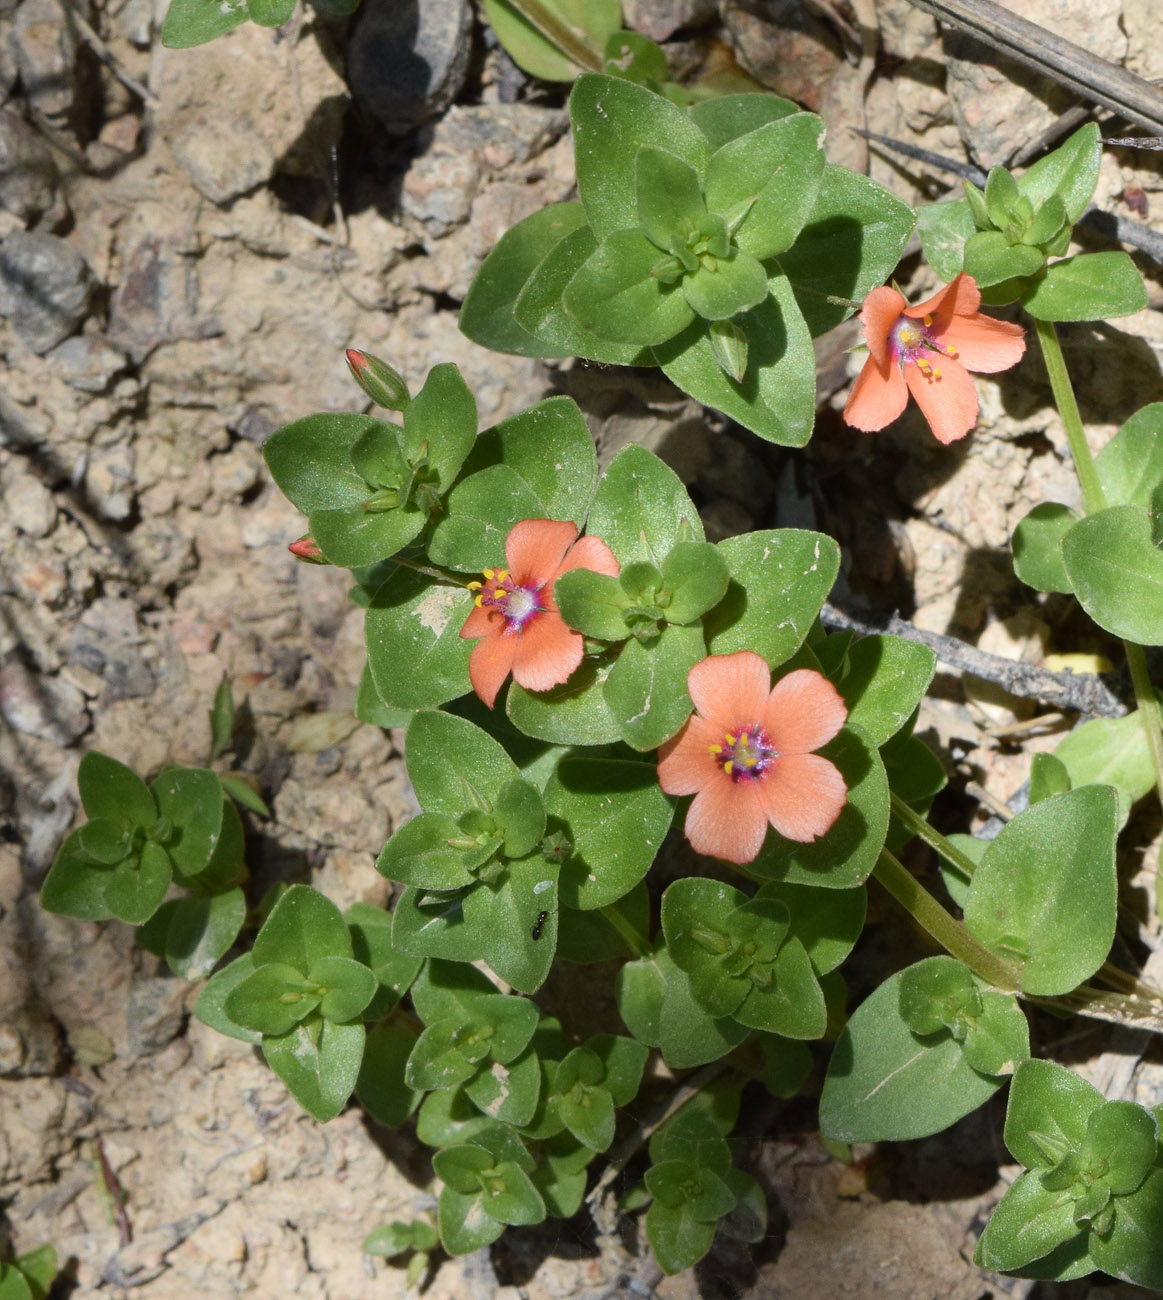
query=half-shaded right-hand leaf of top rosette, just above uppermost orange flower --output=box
[778,164,920,337]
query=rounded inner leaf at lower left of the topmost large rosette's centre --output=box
[561,230,694,347]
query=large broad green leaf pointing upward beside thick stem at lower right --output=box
[965,785,1118,997]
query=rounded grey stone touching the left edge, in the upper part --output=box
[0,230,94,352]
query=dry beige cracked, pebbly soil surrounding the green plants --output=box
[0,0,1163,1300]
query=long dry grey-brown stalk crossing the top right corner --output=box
[911,0,1163,135]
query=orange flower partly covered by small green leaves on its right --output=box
[460,519,619,709]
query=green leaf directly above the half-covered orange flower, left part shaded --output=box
[464,397,598,527]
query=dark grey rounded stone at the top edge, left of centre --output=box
[347,0,472,135]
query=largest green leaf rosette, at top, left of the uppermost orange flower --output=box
[460,76,912,446]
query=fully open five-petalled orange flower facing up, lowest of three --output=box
[659,650,849,865]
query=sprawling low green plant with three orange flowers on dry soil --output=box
[43,25,1163,1290]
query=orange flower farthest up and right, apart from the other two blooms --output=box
[843,272,1025,442]
